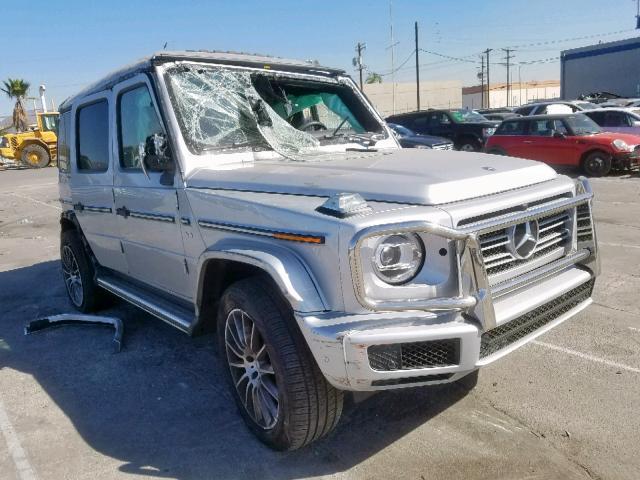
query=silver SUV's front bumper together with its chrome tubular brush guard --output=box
[296,179,600,390]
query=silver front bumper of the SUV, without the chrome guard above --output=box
[296,266,594,391]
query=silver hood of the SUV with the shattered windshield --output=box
[186,149,556,205]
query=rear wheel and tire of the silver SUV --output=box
[60,230,104,313]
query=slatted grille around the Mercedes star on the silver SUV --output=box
[479,210,573,276]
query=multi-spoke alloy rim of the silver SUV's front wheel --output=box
[224,308,280,430]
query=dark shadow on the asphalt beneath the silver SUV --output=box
[0,261,465,479]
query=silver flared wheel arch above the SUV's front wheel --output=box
[193,240,327,331]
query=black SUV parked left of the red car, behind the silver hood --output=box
[387,109,498,152]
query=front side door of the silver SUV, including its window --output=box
[113,75,191,299]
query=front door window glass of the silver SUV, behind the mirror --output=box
[118,85,164,169]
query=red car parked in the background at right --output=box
[485,113,640,177]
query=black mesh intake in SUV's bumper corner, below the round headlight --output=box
[367,338,460,372]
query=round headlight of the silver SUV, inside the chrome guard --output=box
[371,233,424,285]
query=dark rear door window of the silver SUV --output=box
[76,100,109,173]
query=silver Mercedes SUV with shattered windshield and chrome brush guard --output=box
[58,52,599,449]
